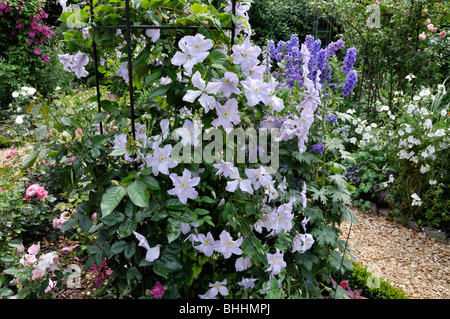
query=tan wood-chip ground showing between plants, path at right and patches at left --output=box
[0,148,450,299]
